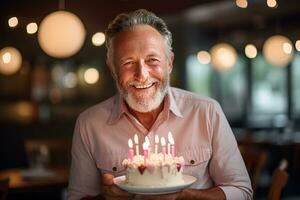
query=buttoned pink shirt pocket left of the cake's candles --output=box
[97,152,127,177]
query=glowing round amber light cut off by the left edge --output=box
[0,47,22,75]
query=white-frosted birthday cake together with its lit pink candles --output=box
[122,133,185,187]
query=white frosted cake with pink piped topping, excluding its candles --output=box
[122,153,184,186]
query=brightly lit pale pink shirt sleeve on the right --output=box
[209,102,253,200]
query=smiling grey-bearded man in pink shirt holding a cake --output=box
[68,9,252,200]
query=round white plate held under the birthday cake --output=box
[114,175,197,195]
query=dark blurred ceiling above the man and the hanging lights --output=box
[0,0,300,32]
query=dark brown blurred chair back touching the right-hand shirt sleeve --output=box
[239,145,268,194]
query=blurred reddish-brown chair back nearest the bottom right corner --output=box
[267,159,288,200]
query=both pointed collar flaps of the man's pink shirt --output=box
[108,88,183,125]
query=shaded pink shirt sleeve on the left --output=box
[68,117,101,200]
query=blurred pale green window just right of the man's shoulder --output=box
[187,55,247,121]
